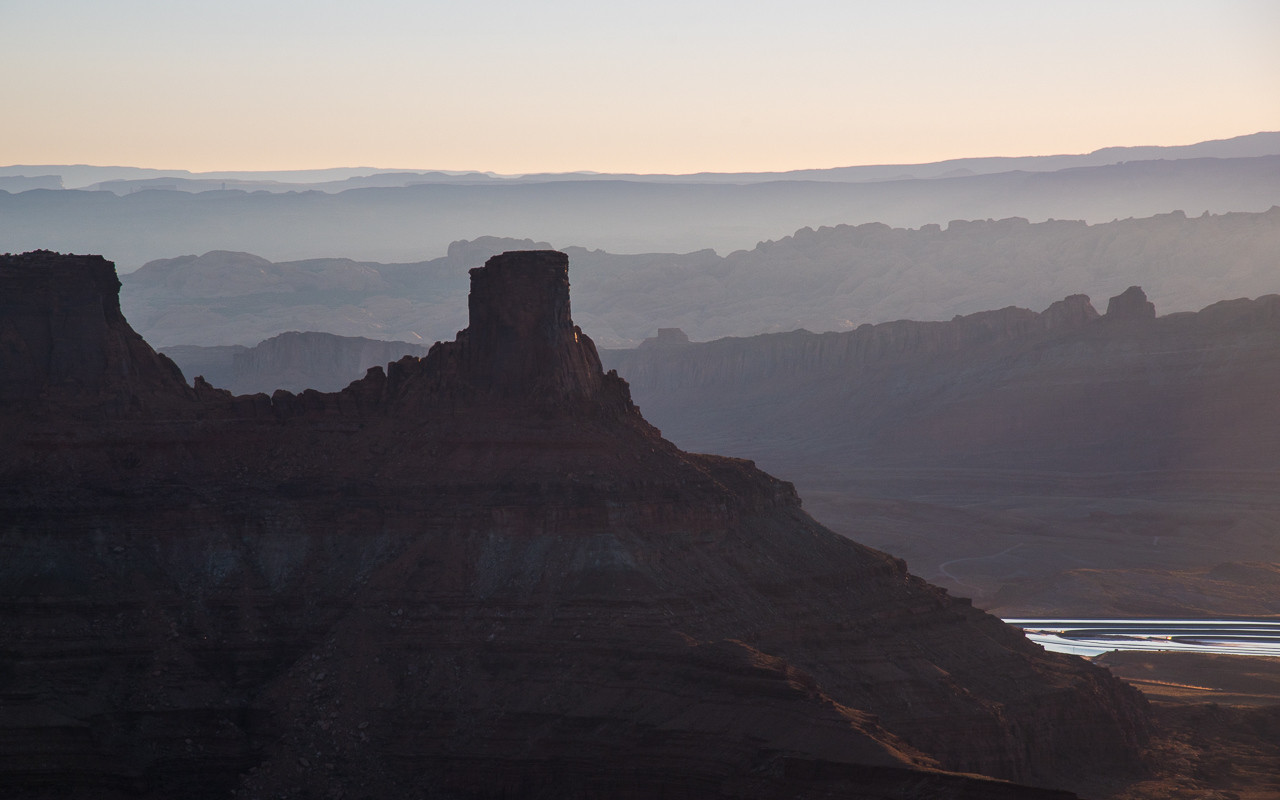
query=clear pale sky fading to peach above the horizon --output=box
[0,0,1280,174]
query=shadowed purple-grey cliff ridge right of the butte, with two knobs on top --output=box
[602,287,1280,474]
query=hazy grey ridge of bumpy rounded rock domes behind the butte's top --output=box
[122,209,1280,348]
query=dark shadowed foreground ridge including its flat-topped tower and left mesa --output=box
[0,251,1148,797]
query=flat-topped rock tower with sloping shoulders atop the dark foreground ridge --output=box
[389,250,634,411]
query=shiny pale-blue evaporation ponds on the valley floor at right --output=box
[1005,620,1280,658]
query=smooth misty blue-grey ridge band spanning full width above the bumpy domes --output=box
[0,156,1280,263]
